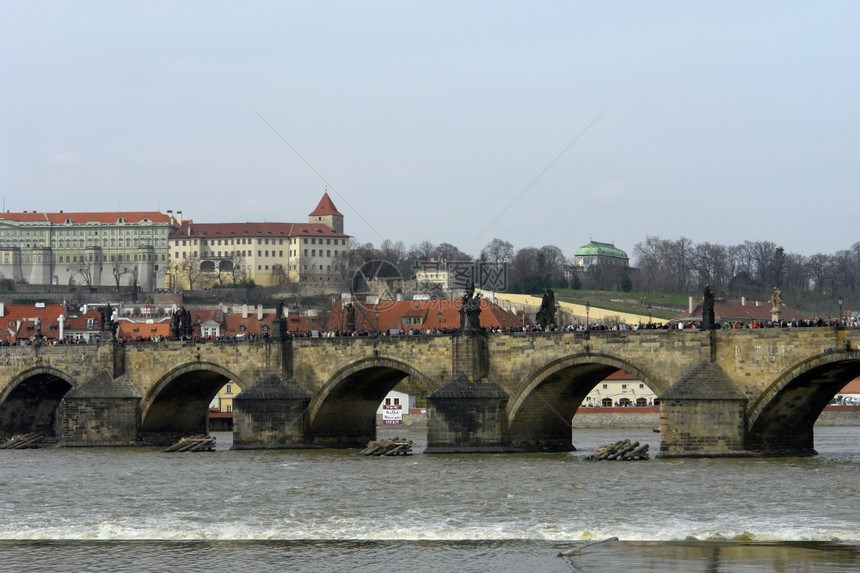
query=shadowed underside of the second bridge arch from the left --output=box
[139,362,245,445]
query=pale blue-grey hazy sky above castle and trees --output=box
[0,0,860,257]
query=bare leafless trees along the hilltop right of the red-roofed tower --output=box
[347,235,860,316]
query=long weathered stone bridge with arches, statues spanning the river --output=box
[0,328,860,457]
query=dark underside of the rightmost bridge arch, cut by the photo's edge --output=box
[747,350,860,455]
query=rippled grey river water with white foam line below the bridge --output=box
[0,426,860,573]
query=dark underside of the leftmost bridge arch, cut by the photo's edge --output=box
[0,363,77,438]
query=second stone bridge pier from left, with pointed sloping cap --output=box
[231,374,313,450]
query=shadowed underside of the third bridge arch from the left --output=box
[308,357,427,447]
